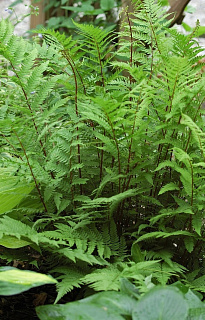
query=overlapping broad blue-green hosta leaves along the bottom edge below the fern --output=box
[37,280,205,320]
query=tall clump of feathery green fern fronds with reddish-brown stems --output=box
[0,0,205,319]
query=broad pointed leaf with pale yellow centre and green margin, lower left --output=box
[0,267,57,296]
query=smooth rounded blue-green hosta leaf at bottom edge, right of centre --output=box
[132,287,188,320]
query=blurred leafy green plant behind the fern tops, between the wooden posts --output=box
[9,0,121,36]
